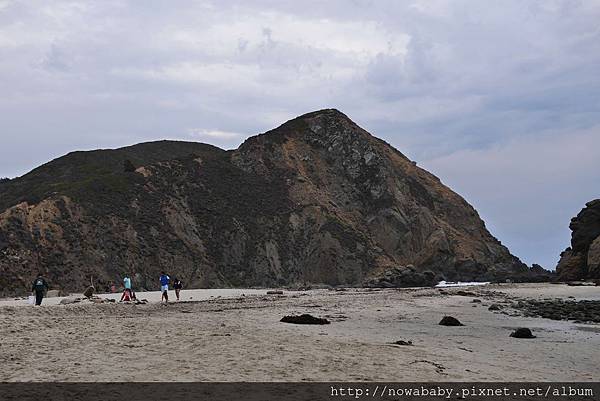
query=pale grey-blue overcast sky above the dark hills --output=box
[0,0,600,268]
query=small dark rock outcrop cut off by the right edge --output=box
[556,199,600,280]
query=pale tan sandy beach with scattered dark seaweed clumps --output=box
[0,284,600,381]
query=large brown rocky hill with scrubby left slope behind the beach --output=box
[0,110,531,293]
